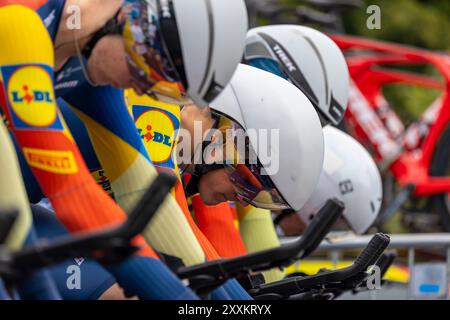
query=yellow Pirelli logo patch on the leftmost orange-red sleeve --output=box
[23,148,78,174]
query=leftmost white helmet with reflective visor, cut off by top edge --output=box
[116,0,248,107]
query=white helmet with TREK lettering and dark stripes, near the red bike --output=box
[245,25,349,125]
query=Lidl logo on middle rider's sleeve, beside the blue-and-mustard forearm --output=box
[133,106,180,169]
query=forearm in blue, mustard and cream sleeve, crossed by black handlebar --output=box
[65,87,205,265]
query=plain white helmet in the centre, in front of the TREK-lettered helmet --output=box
[211,64,324,210]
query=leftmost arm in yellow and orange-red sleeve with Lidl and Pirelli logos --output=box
[0,6,151,255]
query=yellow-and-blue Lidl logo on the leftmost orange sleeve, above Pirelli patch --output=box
[1,65,63,130]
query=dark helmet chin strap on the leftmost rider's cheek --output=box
[73,9,123,87]
